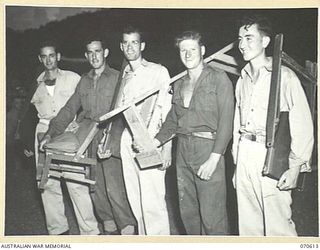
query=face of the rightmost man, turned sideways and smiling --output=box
[238,24,270,61]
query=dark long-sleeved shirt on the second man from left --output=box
[47,65,119,137]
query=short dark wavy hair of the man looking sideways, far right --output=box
[237,14,273,38]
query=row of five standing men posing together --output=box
[23,13,313,236]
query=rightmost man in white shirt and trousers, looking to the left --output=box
[233,16,313,236]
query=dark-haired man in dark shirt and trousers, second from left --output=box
[40,39,136,234]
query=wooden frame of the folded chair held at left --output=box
[37,122,99,192]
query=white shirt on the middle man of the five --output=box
[117,59,171,138]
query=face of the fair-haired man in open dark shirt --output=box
[179,39,205,69]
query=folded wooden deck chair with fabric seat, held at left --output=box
[37,120,99,192]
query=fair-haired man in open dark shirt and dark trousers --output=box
[155,31,234,235]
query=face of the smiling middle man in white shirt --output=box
[120,33,145,61]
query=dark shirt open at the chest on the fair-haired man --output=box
[156,65,234,154]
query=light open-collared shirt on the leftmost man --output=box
[31,69,80,125]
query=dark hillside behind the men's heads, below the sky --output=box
[6,6,317,98]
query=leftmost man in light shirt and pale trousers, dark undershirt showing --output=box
[31,42,99,235]
